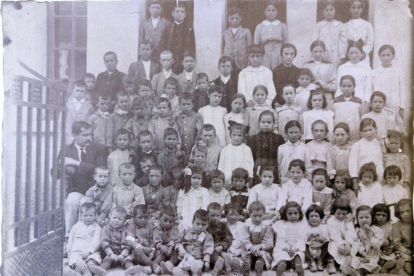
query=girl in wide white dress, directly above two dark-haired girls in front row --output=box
[276,159,312,212]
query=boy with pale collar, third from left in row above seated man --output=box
[107,91,132,147]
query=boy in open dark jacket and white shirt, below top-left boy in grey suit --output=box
[128,40,160,83]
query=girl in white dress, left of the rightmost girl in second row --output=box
[335,41,372,114]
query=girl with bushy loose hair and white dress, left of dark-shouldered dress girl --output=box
[302,89,334,142]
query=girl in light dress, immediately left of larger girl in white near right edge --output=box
[326,123,351,179]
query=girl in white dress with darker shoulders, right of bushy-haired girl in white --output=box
[333,75,362,144]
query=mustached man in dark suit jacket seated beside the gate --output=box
[51,121,108,235]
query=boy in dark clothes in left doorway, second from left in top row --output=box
[159,2,196,75]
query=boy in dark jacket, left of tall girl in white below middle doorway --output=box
[212,56,238,112]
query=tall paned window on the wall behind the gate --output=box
[48,1,87,81]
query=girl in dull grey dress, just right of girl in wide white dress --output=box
[312,168,332,224]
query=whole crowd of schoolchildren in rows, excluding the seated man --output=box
[65,0,412,276]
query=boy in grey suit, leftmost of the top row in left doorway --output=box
[139,0,171,56]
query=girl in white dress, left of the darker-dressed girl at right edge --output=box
[348,118,384,194]
